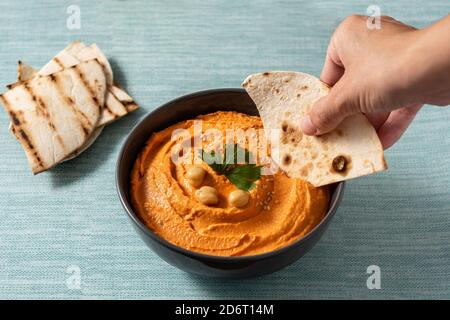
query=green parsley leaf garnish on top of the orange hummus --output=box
[199,144,262,191]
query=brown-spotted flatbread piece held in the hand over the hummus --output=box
[242,71,387,187]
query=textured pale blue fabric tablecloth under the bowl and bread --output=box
[0,0,450,299]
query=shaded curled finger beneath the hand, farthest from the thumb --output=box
[377,104,422,149]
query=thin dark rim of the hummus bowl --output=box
[115,88,345,262]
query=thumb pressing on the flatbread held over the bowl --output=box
[300,78,359,135]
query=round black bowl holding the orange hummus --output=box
[116,89,344,278]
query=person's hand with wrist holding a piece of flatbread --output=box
[301,16,450,149]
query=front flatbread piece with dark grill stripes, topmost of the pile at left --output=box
[0,59,106,174]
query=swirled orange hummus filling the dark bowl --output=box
[130,112,329,256]
